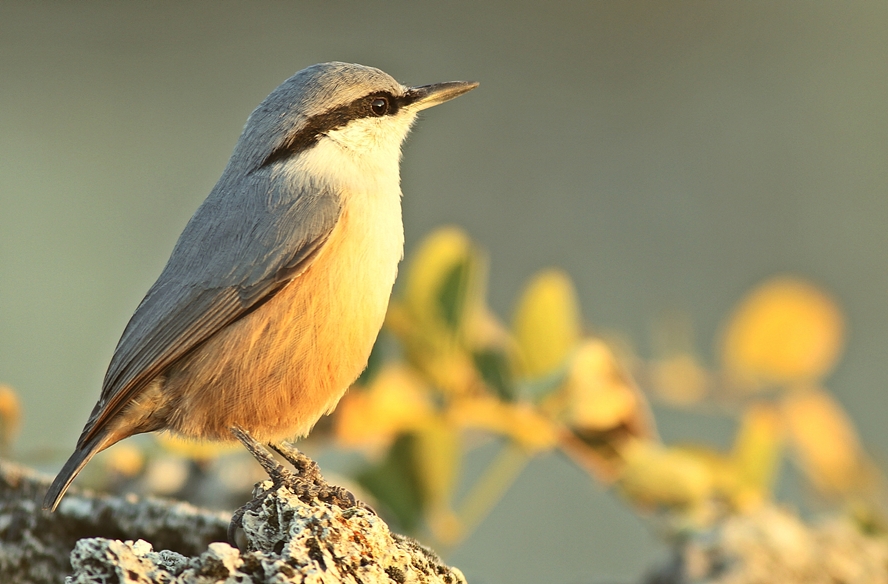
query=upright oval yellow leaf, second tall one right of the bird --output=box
[512,269,582,377]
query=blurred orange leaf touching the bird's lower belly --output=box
[335,365,432,449]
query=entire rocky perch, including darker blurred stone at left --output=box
[0,463,465,584]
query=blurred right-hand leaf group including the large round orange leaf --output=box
[639,276,884,523]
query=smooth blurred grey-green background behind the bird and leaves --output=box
[0,0,888,583]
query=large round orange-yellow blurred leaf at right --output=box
[722,277,844,384]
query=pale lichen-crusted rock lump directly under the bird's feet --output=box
[67,482,465,584]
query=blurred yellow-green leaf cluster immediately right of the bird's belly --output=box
[334,228,655,544]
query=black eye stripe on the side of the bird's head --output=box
[260,91,412,168]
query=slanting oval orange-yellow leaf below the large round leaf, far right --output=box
[783,389,868,493]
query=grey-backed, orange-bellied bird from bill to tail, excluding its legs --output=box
[43,62,478,511]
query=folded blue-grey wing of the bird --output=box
[79,175,340,444]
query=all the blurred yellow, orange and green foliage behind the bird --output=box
[24,227,886,549]
